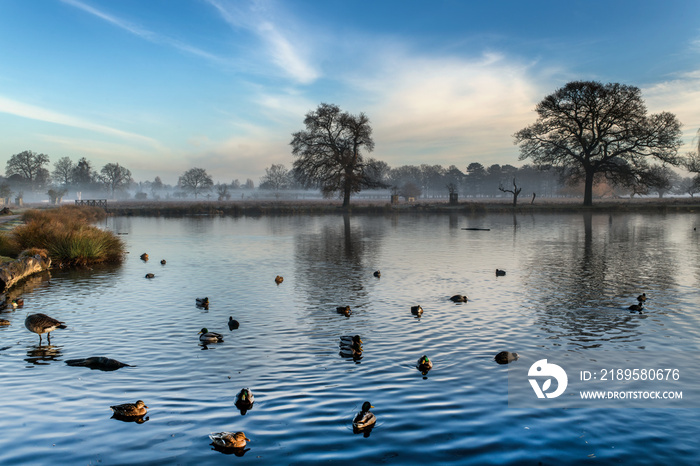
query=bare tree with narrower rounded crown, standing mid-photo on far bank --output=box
[291,103,385,207]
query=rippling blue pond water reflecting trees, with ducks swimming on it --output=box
[0,213,700,465]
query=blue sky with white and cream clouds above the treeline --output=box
[0,0,700,184]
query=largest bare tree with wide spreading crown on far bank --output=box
[514,81,682,205]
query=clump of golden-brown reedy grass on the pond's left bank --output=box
[0,206,124,266]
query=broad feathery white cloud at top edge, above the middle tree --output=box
[206,0,320,84]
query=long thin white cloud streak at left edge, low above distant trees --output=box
[0,95,164,150]
